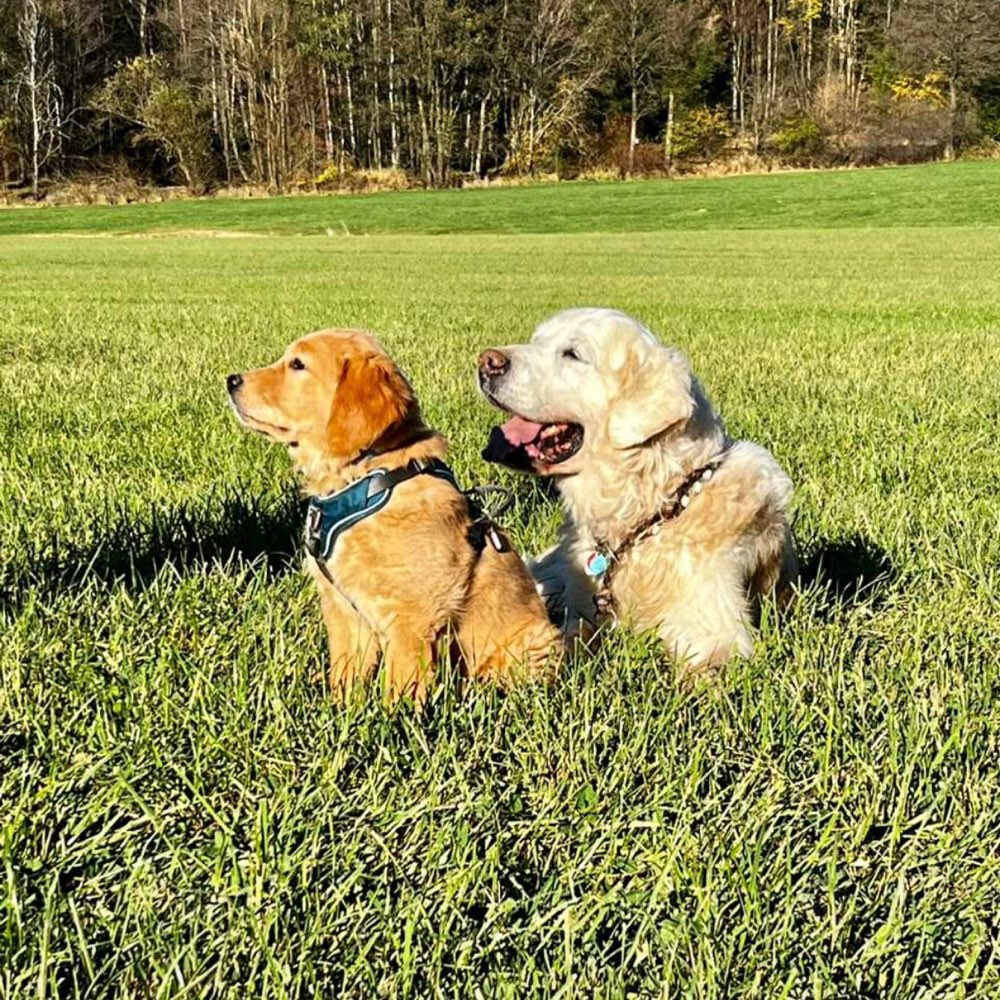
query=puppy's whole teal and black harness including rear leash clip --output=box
[305,458,513,583]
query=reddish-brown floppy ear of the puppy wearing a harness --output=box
[327,354,416,455]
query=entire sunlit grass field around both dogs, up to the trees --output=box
[0,164,1000,998]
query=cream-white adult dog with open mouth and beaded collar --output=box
[479,308,797,671]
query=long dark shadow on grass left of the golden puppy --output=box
[0,495,304,612]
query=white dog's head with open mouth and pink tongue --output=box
[479,308,707,475]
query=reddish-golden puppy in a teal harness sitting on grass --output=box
[226,330,561,704]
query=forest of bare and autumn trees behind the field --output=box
[0,0,1000,200]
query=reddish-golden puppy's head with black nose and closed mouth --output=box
[226,330,421,463]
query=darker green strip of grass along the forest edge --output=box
[0,161,1000,236]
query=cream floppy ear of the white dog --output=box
[608,344,694,448]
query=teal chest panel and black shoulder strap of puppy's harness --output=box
[306,458,461,573]
